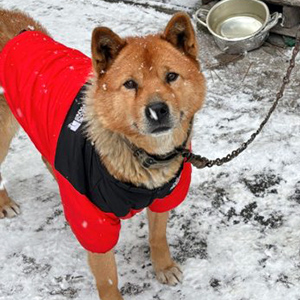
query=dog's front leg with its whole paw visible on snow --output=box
[147,209,182,285]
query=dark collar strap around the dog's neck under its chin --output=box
[124,119,193,169]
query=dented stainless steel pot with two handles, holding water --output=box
[195,0,282,53]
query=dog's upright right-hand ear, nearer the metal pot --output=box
[163,12,198,59]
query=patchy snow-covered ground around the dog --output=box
[0,0,300,300]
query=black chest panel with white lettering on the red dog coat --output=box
[54,86,182,217]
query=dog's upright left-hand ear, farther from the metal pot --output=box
[92,27,126,76]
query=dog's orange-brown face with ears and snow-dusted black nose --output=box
[92,14,205,153]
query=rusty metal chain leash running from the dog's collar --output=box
[177,26,300,169]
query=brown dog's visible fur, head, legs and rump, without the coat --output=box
[0,10,205,300]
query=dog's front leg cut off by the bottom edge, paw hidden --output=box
[88,250,123,300]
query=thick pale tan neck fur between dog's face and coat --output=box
[85,84,188,189]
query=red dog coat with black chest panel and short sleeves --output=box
[0,31,191,253]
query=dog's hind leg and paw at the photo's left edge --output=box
[0,95,20,218]
